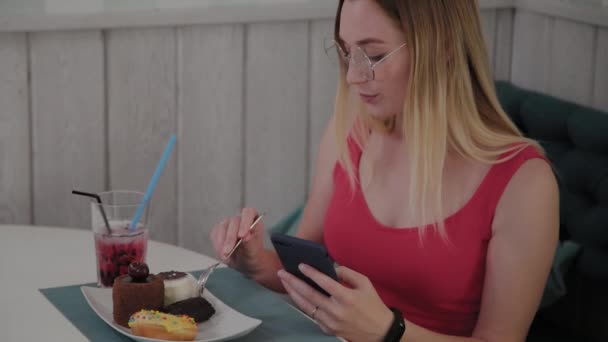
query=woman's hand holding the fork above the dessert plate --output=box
[210,208,264,278]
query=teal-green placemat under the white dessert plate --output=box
[40,268,338,342]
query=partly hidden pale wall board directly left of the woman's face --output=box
[308,20,338,187]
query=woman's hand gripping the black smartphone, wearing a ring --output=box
[277,264,393,341]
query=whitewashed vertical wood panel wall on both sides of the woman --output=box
[0,9,608,253]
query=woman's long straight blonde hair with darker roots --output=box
[334,0,542,238]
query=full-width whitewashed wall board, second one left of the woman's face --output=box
[245,22,309,225]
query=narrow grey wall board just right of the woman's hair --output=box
[494,9,514,81]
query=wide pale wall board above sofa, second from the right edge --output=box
[548,19,594,105]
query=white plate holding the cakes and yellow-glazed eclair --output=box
[80,286,262,342]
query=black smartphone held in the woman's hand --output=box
[270,233,338,296]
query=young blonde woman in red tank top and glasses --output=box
[211,0,559,342]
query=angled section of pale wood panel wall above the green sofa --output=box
[511,11,608,111]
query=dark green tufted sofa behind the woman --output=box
[270,81,608,342]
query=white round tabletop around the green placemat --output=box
[0,225,215,342]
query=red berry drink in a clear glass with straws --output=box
[94,221,148,287]
